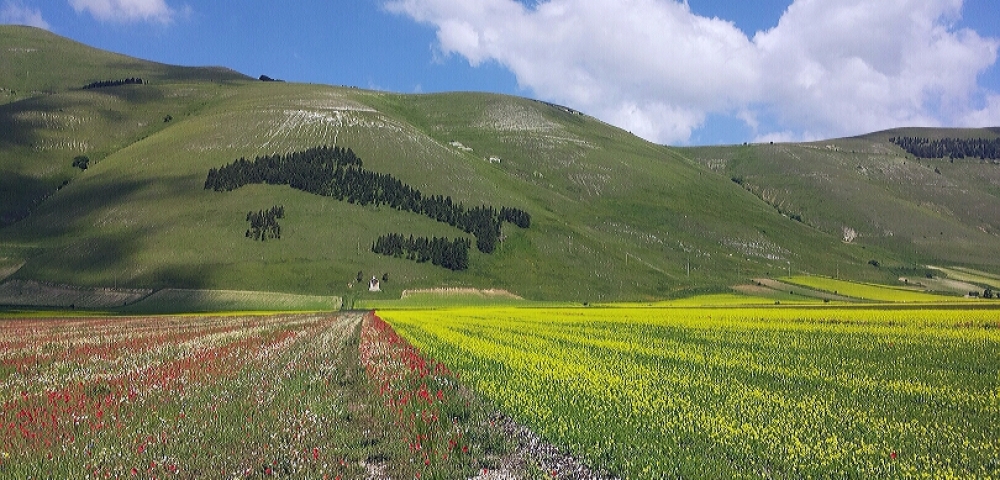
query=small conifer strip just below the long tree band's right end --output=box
[372,233,472,271]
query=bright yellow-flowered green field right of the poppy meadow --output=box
[380,306,1000,478]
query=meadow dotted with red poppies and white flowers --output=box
[0,313,503,479]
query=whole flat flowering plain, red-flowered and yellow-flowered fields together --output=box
[0,302,1000,480]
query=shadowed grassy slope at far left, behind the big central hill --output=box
[0,25,246,226]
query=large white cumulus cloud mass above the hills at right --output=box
[386,0,998,143]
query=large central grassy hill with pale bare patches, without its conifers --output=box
[0,29,992,303]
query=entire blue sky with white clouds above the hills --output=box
[0,0,1000,145]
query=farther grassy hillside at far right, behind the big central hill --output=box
[684,129,1000,269]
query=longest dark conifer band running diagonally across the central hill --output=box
[205,146,531,264]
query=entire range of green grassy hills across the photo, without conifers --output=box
[0,26,1000,301]
